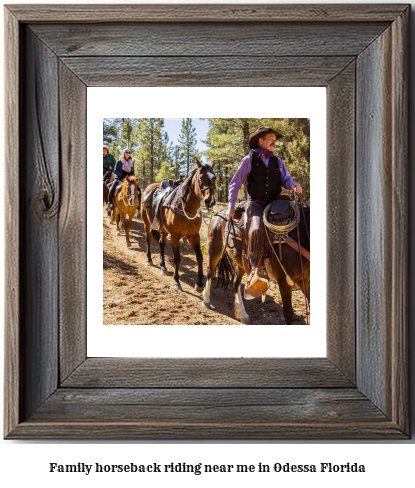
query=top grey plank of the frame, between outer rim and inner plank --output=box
[32,22,389,57]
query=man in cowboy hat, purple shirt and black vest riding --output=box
[226,127,303,299]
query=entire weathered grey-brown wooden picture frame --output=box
[4,5,410,439]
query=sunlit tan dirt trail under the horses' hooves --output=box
[103,212,305,325]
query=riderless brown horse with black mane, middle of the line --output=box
[141,159,216,293]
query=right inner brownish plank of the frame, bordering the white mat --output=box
[327,62,356,382]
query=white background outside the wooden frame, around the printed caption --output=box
[0,0,415,488]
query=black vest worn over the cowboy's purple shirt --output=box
[247,152,281,204]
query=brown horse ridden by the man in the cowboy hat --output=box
[203,207,310,324]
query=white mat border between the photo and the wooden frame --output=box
[87,87,326,357]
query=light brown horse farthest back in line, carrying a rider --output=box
[113,176,140,247]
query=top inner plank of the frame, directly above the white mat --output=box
[62,56,353,86]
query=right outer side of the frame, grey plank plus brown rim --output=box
[357,15,408,430]
